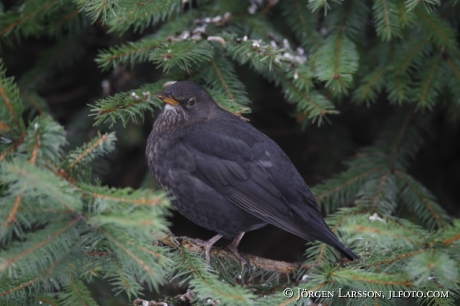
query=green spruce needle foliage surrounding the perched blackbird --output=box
[0,0,460,305]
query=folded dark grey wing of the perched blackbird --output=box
[181,118,323,240]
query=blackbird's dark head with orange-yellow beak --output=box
[155,81,219,124]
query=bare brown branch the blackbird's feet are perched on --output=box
[156,233,314,274]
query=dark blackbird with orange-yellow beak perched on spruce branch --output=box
[146,80,359,266]
